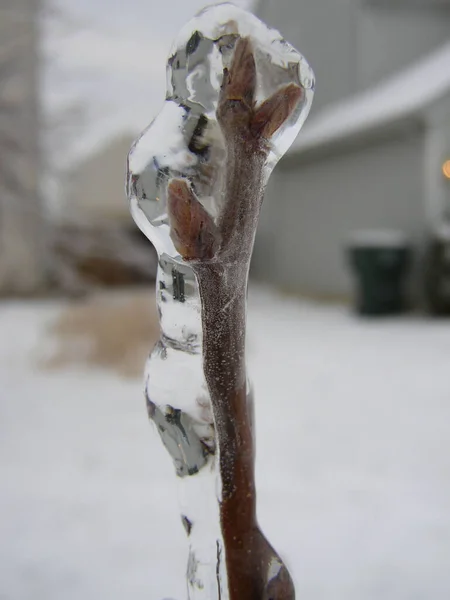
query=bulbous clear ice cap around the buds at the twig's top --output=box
[128,3,314,261]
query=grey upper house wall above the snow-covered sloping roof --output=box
[257,0,450,115]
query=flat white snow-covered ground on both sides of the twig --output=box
[0,288,450,600]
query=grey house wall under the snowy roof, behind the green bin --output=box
[252,131,425,297]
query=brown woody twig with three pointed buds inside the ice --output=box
[168,38,302,600]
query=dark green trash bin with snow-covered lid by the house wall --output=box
[348,231,411,316]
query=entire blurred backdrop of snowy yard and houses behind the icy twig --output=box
[0,0,450,600]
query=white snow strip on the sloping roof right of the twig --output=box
[289,42,450,154]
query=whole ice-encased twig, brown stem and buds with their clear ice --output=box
[127,4,314,600]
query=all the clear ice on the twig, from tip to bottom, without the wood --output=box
[127,4,314,600]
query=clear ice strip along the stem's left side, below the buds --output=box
[145,254,228,600]
